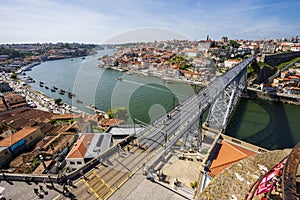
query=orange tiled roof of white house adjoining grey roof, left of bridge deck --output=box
[67,134,94,158]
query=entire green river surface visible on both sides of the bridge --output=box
[22,50,300,149]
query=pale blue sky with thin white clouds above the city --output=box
[0,0,300,44]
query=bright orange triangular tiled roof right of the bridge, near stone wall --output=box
[209,140,256,177]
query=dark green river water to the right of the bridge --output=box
[226,99,300,149]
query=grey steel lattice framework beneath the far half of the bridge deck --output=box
[206,69,247,131]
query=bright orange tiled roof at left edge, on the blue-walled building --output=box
[0,126,40,147]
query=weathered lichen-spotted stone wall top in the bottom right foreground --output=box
[194,149,291,200]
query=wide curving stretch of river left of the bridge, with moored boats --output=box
[26,50,194,123]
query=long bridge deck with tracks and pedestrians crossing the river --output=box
[57,57,254,199]
